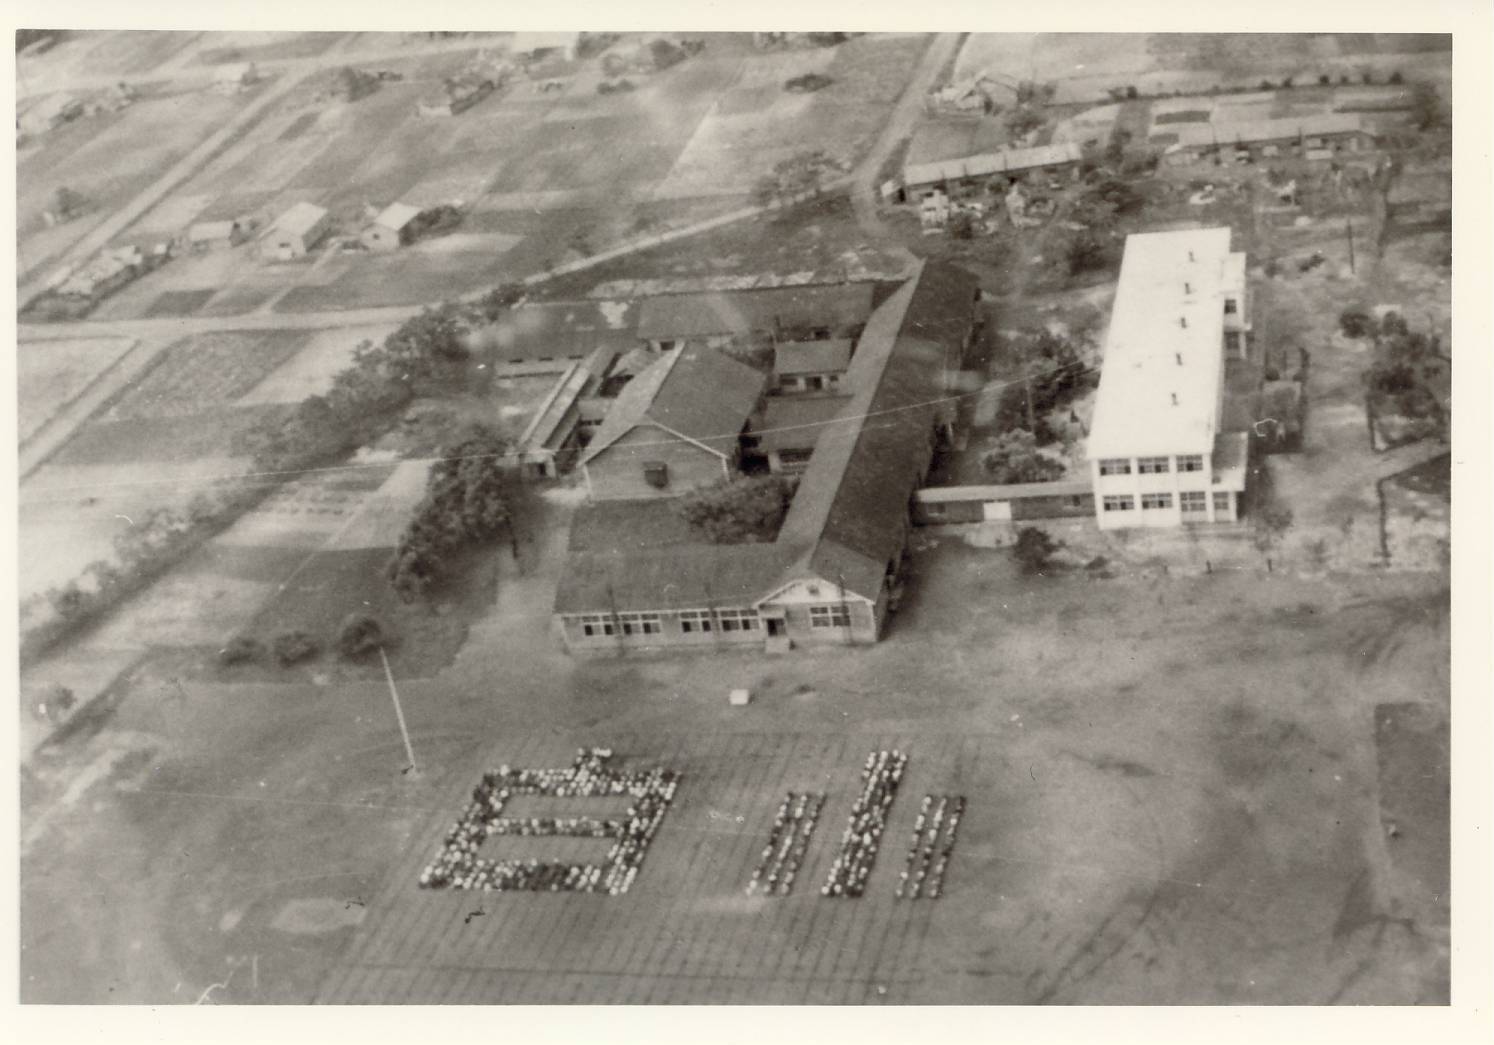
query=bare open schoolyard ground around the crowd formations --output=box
[22,496,1446,1003]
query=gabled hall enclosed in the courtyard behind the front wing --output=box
[581,345,766,501]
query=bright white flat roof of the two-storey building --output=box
[1088,227,1230,459]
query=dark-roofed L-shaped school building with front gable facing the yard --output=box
[554,262,979,653]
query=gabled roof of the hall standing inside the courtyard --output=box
[581,347,768,463]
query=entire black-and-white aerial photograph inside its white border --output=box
[15,10,1481,1041]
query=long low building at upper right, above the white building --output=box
[1149,112,1374,166]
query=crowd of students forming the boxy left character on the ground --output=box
[420,747,678,896]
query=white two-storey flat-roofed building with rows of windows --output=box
[1088,227,1250,529]
